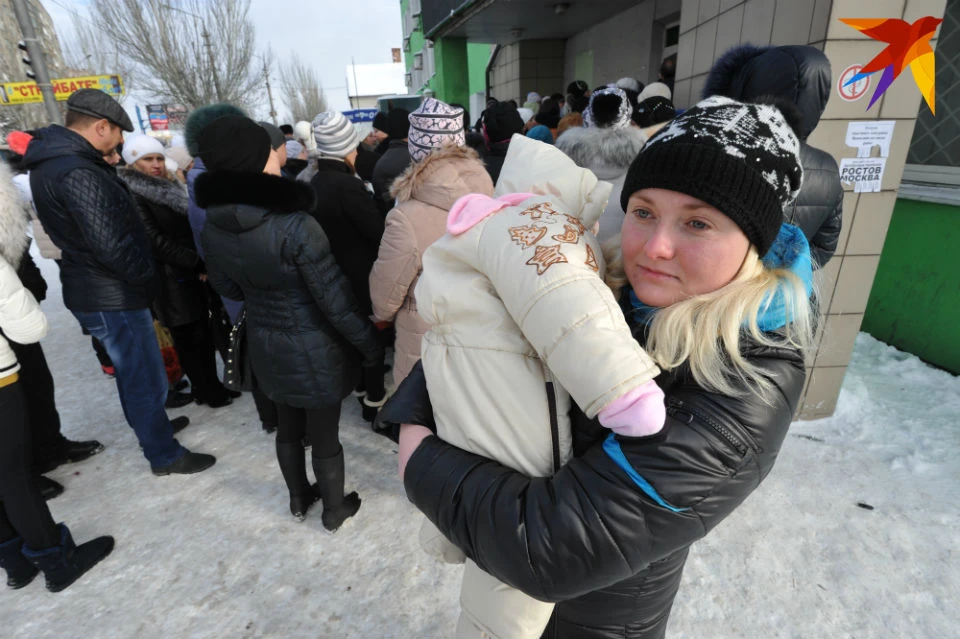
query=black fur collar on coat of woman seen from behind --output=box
[194,171,317,213]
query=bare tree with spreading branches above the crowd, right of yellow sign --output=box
[89,0,262,108]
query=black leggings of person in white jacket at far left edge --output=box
[0,382,60,550]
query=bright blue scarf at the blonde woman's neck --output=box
[627,224,813,332]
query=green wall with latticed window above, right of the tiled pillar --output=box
[863,0,960,375]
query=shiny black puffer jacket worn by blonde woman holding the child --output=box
[381,324,804,639]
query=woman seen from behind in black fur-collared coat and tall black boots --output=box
[195,116,383,530]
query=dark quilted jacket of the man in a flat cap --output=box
[24,125,159,312]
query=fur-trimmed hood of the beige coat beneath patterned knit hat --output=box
[390,145,493,209]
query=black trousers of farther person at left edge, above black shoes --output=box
[10,342,66,465]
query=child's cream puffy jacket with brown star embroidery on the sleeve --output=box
[416,135,662,476]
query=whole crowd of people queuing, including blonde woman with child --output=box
[0,47,842,639]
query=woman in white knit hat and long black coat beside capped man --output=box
[119,140,238,408]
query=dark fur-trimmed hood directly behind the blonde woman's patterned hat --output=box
[702,44,832,142]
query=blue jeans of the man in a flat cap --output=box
[73,309,186,466]
